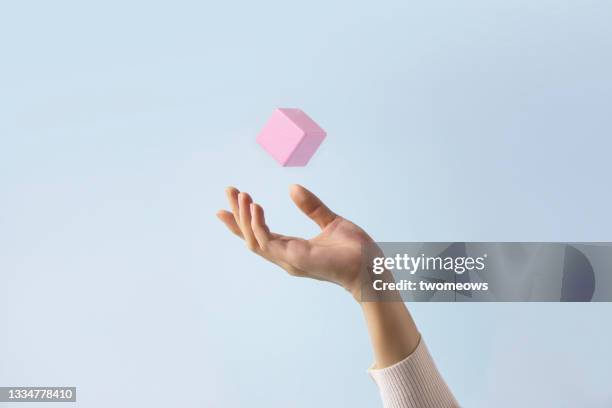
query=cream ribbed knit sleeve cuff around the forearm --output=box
[368,339,459,408]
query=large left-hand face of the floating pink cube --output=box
[257,109,305,166]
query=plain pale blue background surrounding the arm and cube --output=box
[0,0,612,408]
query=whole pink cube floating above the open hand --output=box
[257,108,325,166]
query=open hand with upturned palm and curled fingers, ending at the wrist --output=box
[217,185,373,301]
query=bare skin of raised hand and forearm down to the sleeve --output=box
[217,185,420,368]
